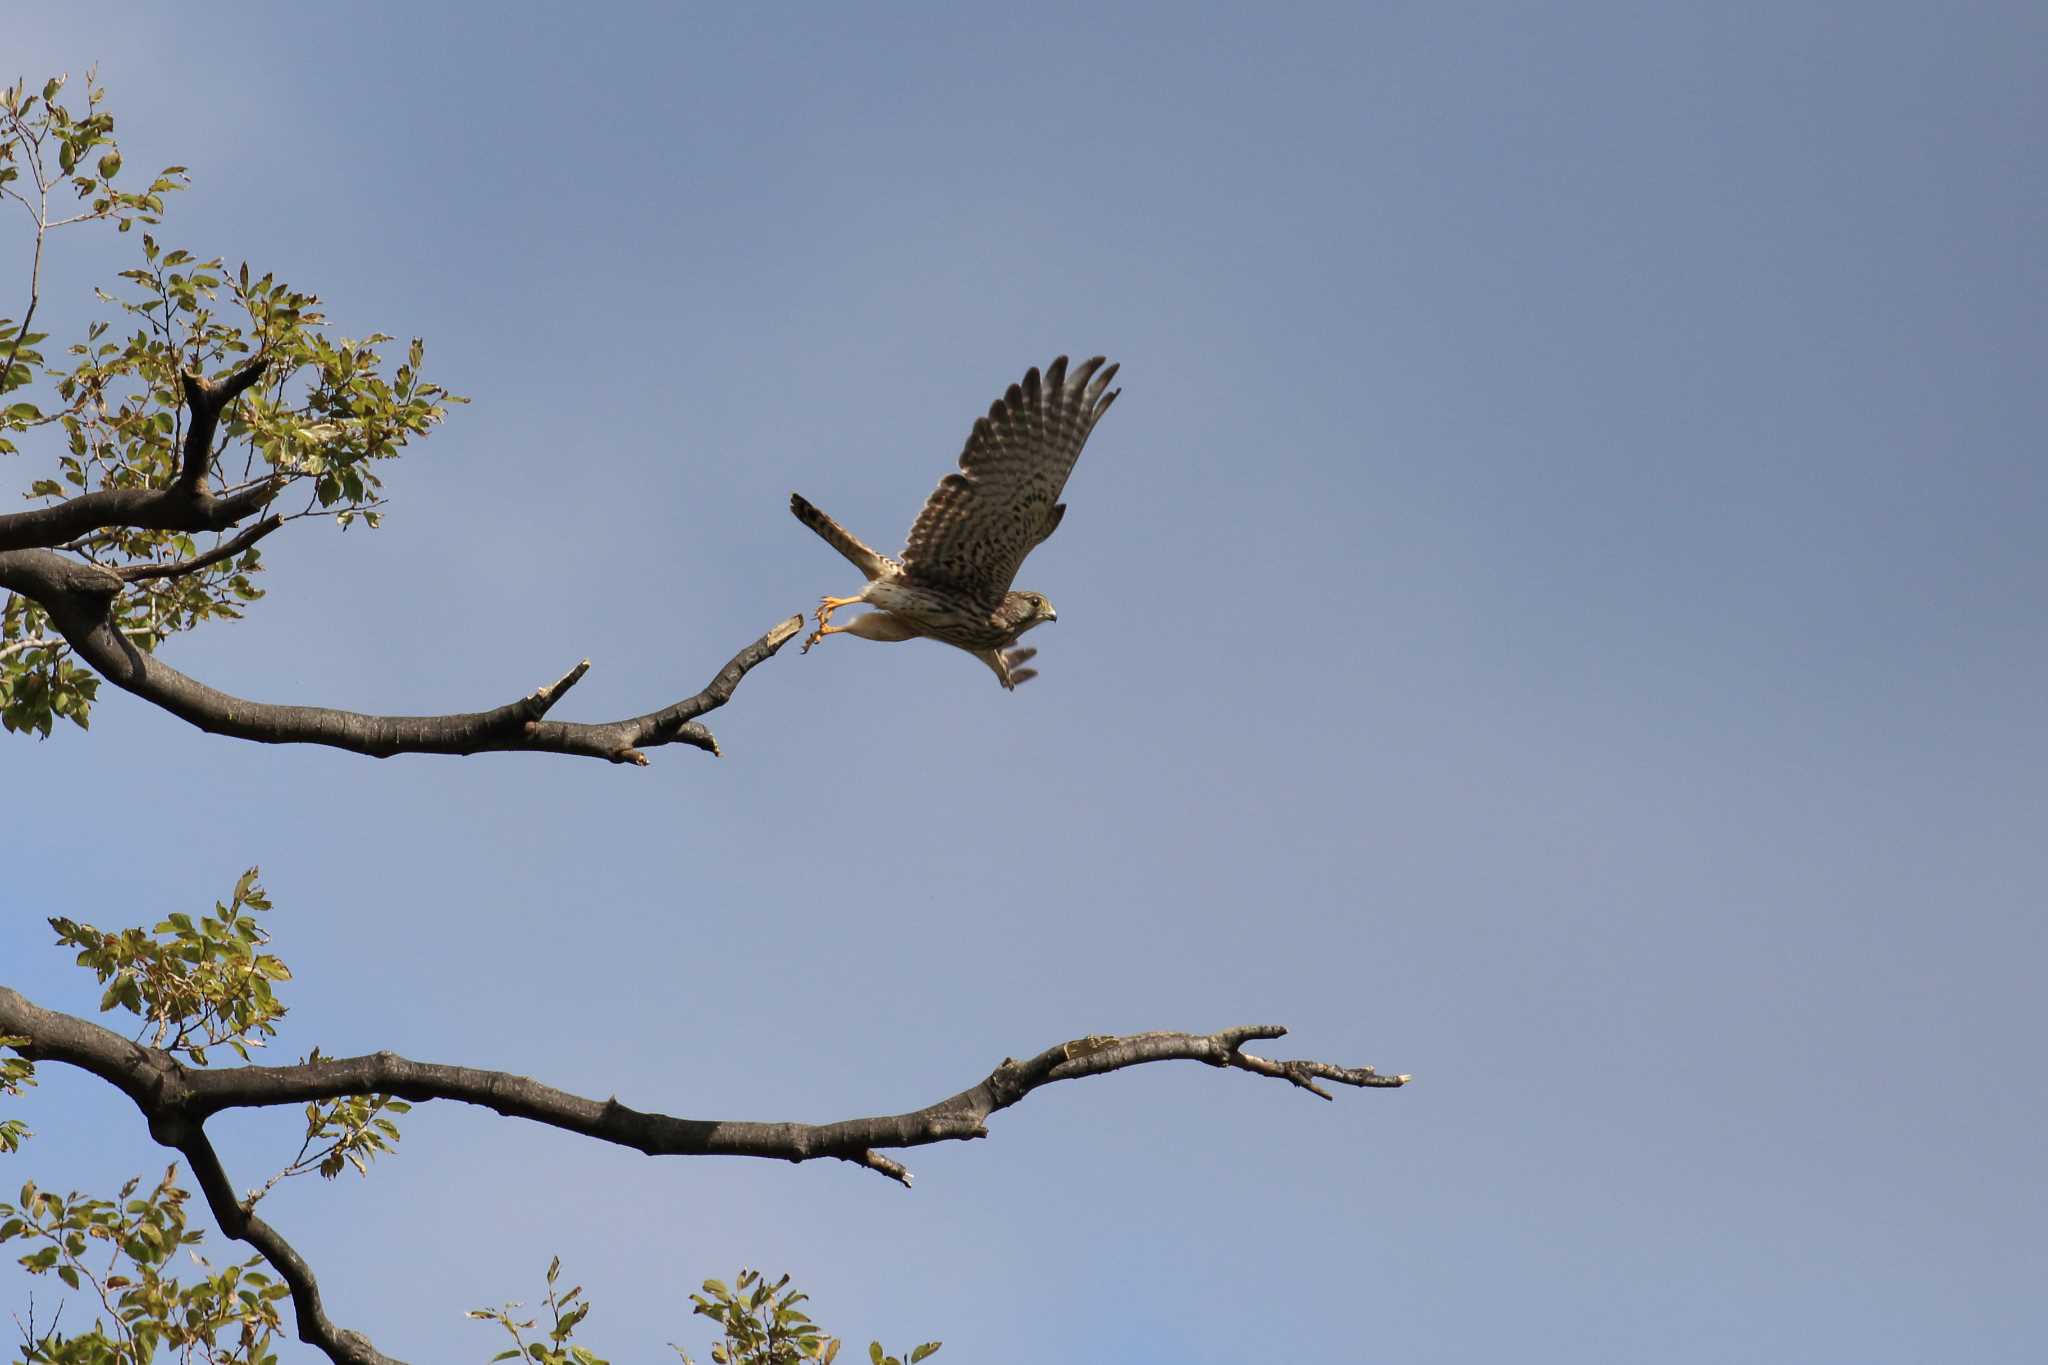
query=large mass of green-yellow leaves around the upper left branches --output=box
[0,74,463,737]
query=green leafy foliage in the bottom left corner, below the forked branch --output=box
[0,1166,289,1365]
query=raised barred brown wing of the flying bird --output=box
[903,356,1118,610]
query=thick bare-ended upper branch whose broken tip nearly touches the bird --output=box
[0,540,803,763]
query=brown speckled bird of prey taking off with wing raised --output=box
[788,356,1120,688]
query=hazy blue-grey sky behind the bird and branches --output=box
[0,4,2048,1365]
